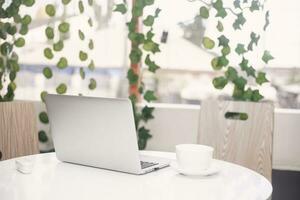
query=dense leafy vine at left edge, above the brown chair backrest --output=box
[0,0,35,102]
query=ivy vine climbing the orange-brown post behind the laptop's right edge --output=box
[114,0,161,149]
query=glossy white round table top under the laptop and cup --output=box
[0,151,272,200]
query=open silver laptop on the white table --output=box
[45,94,169,174]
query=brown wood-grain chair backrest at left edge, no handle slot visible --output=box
[0,101,39,160]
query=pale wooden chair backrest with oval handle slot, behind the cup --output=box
[198,100,274,181]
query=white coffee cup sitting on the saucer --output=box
[176,144,214,173]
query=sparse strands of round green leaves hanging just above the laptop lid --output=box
[39,0,97,147]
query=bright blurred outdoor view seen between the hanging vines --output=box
[12,0,300,109]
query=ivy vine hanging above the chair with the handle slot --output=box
[200,0,274,102]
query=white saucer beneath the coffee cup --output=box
[170,161,220,176]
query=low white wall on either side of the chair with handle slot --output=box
[147,104,300,171]
